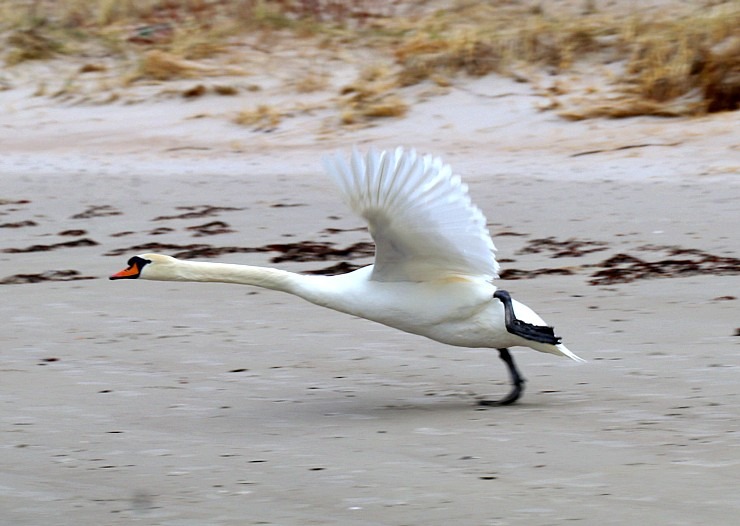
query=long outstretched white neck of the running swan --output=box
[152,260,307,295]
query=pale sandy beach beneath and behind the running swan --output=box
[0,31,740,526]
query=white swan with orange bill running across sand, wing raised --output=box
[110,147,585,405]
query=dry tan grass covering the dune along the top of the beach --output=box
[0,0,740,119]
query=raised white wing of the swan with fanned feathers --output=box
[324,148,498,281]
